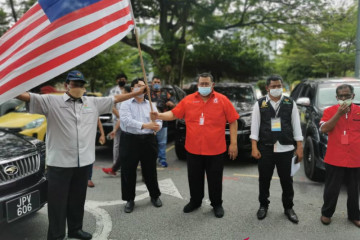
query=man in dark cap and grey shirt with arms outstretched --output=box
[17,70,145,240]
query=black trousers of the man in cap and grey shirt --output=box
[47,165,92,240]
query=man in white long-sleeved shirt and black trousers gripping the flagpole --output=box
[120,79,162,213]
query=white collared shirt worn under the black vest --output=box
[250,95,303,152]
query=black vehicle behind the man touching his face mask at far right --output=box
[290,78,360,181]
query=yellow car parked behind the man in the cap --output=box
[0,102,47,141]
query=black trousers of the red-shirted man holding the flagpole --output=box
[187,153,224,207]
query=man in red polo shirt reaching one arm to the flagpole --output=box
[151,73,239,218]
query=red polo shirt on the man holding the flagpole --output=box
[171,91,239,155]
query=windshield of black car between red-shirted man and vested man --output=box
[214,85,255,103]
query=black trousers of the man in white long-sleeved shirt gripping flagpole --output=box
[120,131,160,201]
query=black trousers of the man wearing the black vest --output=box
[258,146,294,209]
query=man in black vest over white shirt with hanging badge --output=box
[250,75,303,223]
